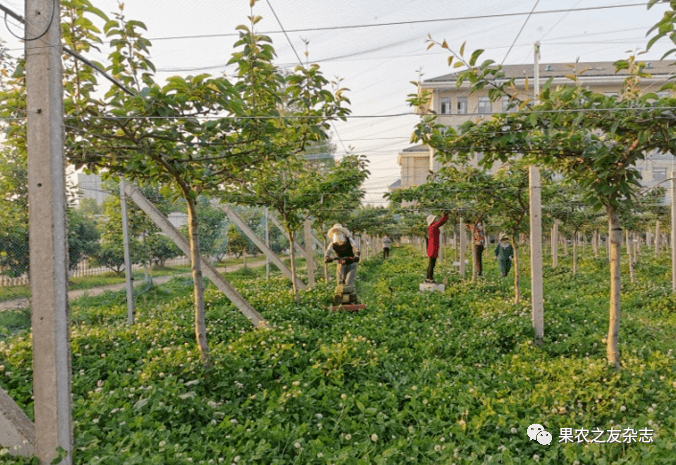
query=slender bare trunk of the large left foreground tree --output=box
[185,195,211,367]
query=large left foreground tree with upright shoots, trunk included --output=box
[0,0,348,364]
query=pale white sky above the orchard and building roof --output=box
[0,0,671,205]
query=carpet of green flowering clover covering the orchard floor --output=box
[0,247,676,465]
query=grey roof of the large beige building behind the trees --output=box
[423,60,676,84]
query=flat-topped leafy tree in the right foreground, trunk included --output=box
[410,42,673,368]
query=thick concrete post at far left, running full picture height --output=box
[25,0,73,464]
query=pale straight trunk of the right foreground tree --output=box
[606,206,622,370]
